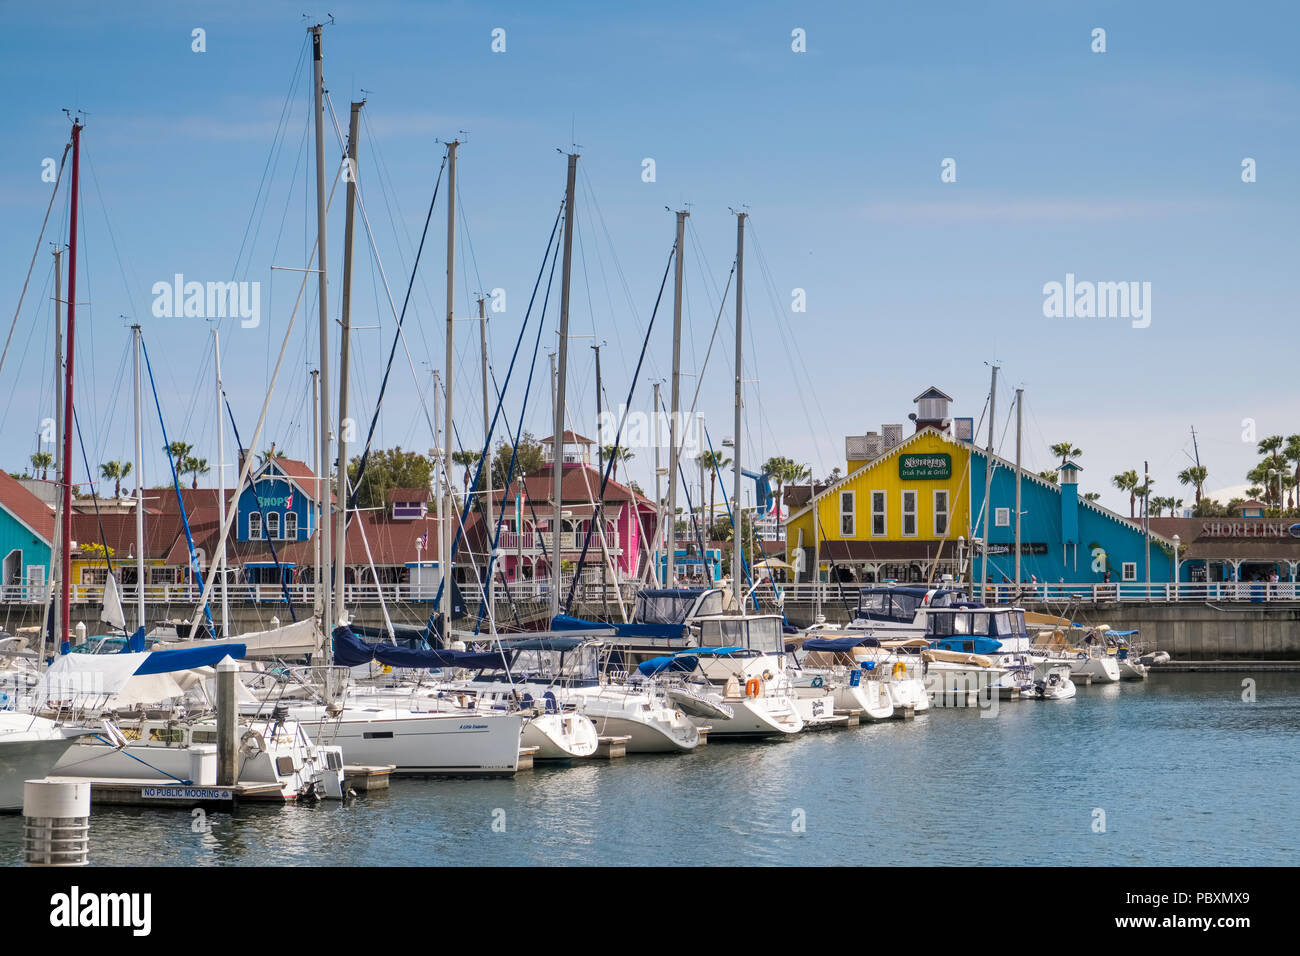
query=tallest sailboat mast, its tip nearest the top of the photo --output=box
[308,23,332,647]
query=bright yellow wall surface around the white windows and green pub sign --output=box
[785,432,970,561]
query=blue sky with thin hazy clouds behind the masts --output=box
[0,0,1300,512]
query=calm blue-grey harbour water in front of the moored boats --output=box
[0,674,1300,866]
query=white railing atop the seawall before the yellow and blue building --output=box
[777,581,1300,607]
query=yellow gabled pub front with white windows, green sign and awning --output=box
[785,421,971,581]
